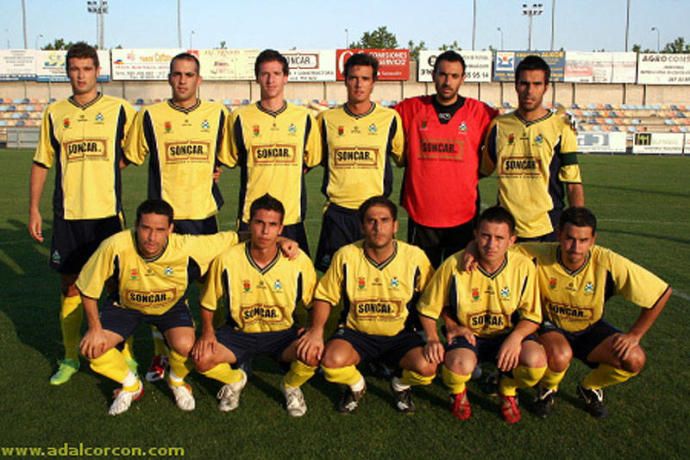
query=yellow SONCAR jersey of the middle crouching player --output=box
[314,241,433,336]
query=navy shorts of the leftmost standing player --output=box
[50,214,124,275]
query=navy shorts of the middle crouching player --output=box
[329,327,425,367]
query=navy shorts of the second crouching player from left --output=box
[216,325,299,365]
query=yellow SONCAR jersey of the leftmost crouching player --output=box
[77,230,238,315]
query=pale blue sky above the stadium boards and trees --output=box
[0,0,690,51]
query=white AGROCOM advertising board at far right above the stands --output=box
[637,53,690,85]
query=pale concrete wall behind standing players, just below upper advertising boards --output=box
[0,80,690,107]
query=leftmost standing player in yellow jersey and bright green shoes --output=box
[28,42,135,385]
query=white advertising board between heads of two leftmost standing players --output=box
[111,48,185,80]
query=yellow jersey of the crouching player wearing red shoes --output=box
[417,251,542,337]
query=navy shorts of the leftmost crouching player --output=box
[100,299,194,339]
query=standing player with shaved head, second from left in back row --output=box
[125,53,230,381]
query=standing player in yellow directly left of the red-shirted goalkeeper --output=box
[316,53,404,272]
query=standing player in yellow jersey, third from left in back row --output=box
[229,49,321,254]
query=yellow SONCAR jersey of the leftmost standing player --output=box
[34,93,136,220]
